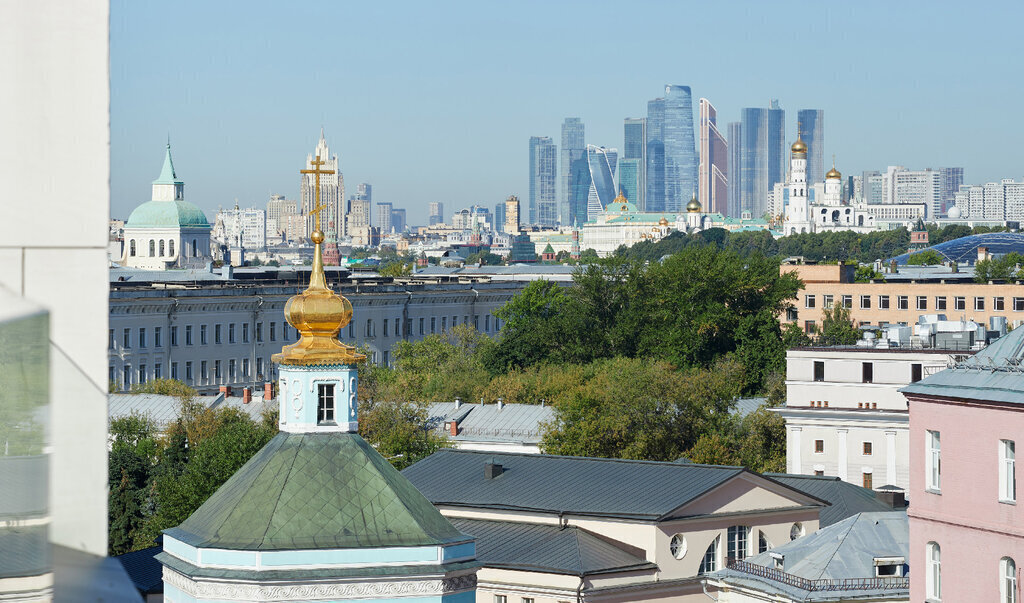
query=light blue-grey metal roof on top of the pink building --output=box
[900,329,1024,404]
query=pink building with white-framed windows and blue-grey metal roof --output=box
[902,329,1024,603]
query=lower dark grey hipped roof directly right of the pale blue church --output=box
[451,517,657,575]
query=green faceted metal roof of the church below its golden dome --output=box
[165,432,469,551]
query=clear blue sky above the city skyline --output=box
[111,0,1024,224]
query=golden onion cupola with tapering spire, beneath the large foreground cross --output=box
[272,229,366,365]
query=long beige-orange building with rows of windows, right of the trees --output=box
[779,263,1024,331]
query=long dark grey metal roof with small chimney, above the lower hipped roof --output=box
[402,448,814,521]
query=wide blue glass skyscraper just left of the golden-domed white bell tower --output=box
[730,99,785,218]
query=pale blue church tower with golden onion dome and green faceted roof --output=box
[157,200,479,603]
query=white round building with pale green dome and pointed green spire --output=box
[121,143,213,270]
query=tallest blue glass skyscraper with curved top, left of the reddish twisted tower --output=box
[663,84,697,212]
